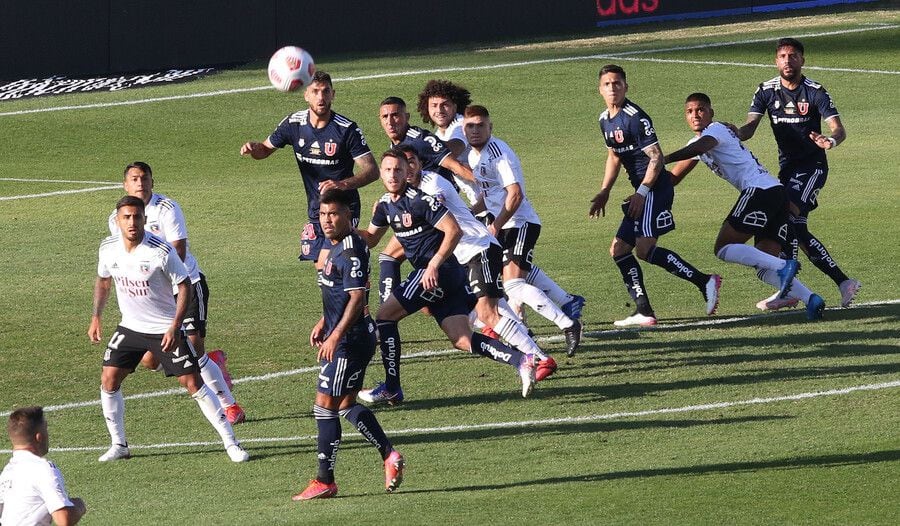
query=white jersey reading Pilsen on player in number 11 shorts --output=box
[97,232,188,334]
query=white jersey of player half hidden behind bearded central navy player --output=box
[419,172,500,265]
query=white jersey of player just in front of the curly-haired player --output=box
[469,137,541,228]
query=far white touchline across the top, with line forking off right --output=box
[0,24,900,117]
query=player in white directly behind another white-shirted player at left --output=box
[109,161,246,424]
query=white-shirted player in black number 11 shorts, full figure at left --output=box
[88,195,249,462]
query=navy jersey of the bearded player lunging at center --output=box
[372,186,456,269]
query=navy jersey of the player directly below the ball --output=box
[269,109,372,223]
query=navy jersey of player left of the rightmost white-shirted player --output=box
[599,99,672,193]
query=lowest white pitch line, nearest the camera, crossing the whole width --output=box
[12,379,900,454]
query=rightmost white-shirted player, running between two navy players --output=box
[665,93,825,320]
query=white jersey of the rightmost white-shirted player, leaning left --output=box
[688,122,781,191]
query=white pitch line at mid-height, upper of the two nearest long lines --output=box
[0,299,900,418]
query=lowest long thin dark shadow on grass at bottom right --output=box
[402,449,900,494]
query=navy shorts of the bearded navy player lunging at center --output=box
[391,263,472,325]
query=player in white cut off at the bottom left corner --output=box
[0,406,87,526]
